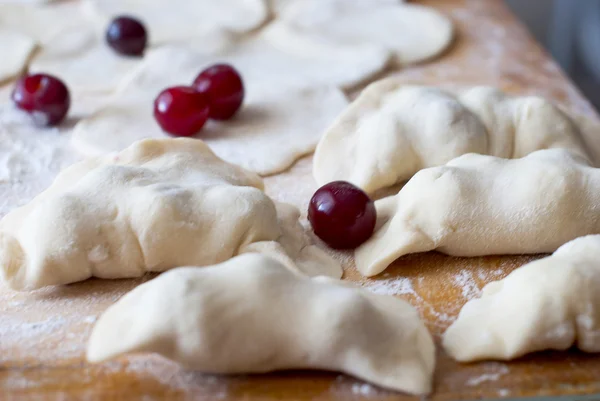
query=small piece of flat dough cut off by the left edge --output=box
[0,30,36,84]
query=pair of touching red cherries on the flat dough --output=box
[154,64,244,136]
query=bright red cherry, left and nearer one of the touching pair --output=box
[154,86,210,136]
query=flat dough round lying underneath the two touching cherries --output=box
[72,44,348,175]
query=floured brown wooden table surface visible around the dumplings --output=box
[0,0,600,401]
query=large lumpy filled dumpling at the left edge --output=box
[0,139,341,290]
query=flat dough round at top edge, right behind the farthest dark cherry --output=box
[83,0,269,45]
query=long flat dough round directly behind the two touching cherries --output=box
[116,34,388,89]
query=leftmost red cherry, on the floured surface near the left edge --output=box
[11,74,71,126]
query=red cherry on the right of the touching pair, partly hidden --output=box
[194,64,244,120]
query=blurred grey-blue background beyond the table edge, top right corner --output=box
[506,0,600,109]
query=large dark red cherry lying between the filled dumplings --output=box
[308,181,377,249]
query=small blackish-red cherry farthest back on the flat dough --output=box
[106,16,148,56]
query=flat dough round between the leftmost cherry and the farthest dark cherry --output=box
[29,25,141,98]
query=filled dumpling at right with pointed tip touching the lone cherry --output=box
[355,149,600,276]
